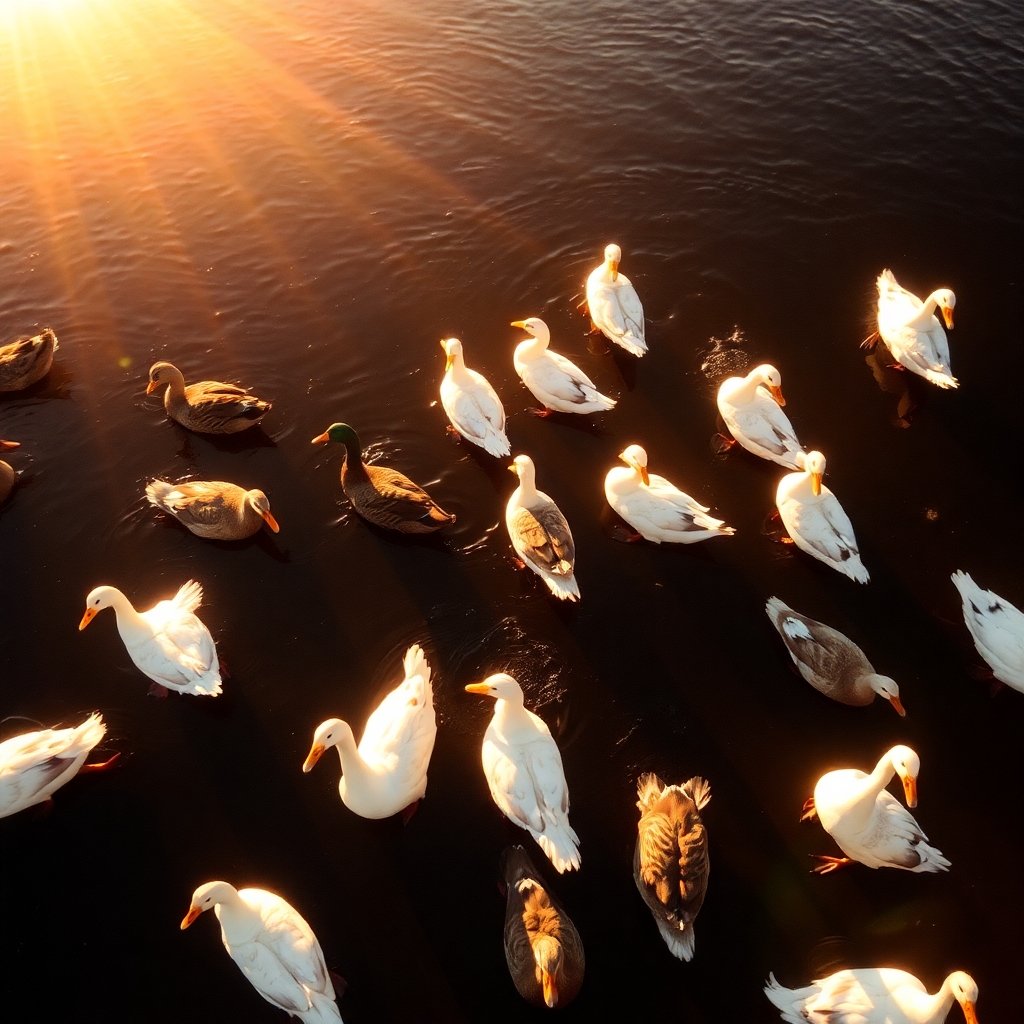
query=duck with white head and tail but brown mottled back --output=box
[505,455,580,601]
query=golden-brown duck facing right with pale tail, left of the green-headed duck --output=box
[145,480,281,541]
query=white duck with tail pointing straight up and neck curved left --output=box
[302,644,437,818]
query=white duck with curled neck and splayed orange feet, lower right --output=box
[800,744,949,874]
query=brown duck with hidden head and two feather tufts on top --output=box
[633,773,711,961]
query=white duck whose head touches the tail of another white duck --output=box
[775,452,870,583]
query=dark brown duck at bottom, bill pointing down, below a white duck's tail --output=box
[502,846,587,1009]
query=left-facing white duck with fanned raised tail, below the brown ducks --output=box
[78,580,220,696]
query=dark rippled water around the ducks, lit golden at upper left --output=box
[0,0,1024,1024]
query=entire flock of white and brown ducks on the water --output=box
[0,245,1024,1024]
